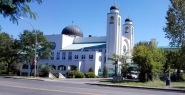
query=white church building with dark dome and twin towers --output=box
[21,5,134,75]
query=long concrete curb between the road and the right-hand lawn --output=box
[85,83,185,92]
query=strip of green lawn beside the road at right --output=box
[99,81,185,88]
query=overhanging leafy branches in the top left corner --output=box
[0,0,43,24]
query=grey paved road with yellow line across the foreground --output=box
[0,77,184,95]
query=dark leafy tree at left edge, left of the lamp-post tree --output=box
[0,32,22,74]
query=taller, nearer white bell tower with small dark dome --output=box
[106,5,121,61]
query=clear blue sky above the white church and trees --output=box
[0,0,170,46]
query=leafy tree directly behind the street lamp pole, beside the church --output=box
[20,30,53,73]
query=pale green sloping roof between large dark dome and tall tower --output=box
[60,43,106,50]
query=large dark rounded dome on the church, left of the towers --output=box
[62,25,83,37]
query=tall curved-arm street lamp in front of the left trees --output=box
[19,17,37,77]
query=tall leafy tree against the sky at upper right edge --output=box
[163,0,185,46]
